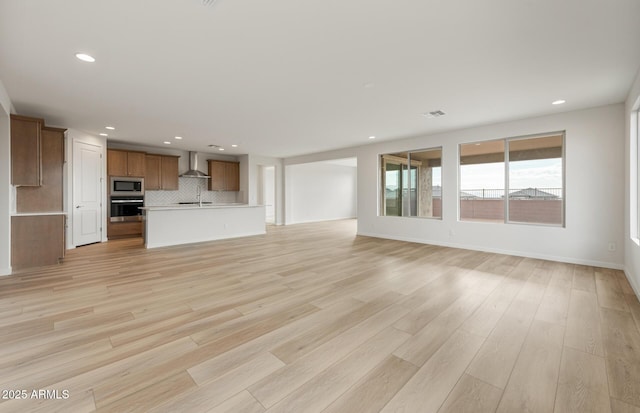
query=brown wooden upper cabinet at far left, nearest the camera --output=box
[11,115,44,186]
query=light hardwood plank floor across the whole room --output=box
[0,220,640,413]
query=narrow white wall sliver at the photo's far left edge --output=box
[0,80,11,275]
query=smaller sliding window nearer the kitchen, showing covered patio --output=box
[380,148,442,218]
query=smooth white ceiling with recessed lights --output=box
[0,0,640,157]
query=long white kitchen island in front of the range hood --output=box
[141,204,266,248]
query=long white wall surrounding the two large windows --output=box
[285,104,624,268]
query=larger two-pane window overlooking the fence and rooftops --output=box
[460,133,564,225]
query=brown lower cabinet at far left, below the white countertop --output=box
[11,214,67,270]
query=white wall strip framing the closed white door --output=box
[64,129,109,249]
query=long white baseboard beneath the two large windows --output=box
[358,231,624,270]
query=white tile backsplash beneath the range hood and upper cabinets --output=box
[144,178,239,206]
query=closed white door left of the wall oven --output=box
[71,142,102,247]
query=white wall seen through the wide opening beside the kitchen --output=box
[285,162,357,224]
